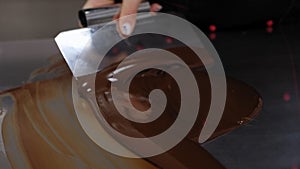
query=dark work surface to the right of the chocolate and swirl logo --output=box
[204,24,300,169]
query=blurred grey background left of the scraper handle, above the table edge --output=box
[0,0,85,41]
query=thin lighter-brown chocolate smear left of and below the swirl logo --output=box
[2,75,156,169]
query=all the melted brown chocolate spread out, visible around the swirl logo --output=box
[2,46,262,169]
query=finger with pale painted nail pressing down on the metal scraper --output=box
[119,0,142,36]
